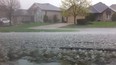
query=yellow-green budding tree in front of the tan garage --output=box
[61,0,90,24]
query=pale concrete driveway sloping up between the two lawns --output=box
[30,23,71,29]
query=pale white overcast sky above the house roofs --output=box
[20,0,116,9]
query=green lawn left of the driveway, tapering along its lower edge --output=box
[0,23,73,32]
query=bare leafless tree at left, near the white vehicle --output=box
[0,0,20,25]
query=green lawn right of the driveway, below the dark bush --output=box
[63,21,116,28]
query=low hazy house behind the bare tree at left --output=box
[0,8,34,24]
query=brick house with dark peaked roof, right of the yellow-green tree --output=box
[89,2,116,21]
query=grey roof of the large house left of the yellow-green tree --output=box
[35,3,60,11]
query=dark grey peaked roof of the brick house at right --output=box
[90,2,109,13]
